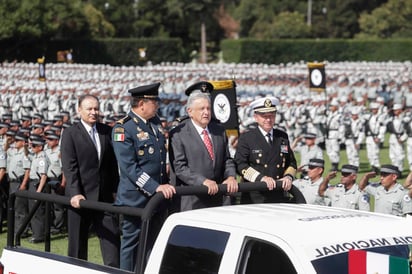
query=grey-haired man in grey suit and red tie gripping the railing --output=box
[169,82,238,211]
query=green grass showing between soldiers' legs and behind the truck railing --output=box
[0,136,408,264]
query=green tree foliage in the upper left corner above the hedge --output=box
[0,0,113,39]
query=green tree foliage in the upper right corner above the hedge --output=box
[356,0,412,38]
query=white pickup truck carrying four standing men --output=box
[0,183,412,274]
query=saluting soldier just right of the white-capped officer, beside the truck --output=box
[319,165,370,211]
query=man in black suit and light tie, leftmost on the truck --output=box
[61,95,120,267]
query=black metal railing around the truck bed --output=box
[7,182,306,273]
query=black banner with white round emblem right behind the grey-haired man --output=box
[209,80,239,135]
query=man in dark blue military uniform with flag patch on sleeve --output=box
[112,83,175,271]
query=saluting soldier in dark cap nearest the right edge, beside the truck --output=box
[359,165,412,216]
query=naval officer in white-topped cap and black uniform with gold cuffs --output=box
[235,97,297,203]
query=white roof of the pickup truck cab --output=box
[167,204,412,258]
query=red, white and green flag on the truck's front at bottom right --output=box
[348,249,410,274]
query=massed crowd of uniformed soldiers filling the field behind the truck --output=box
[0,62,412,238]
